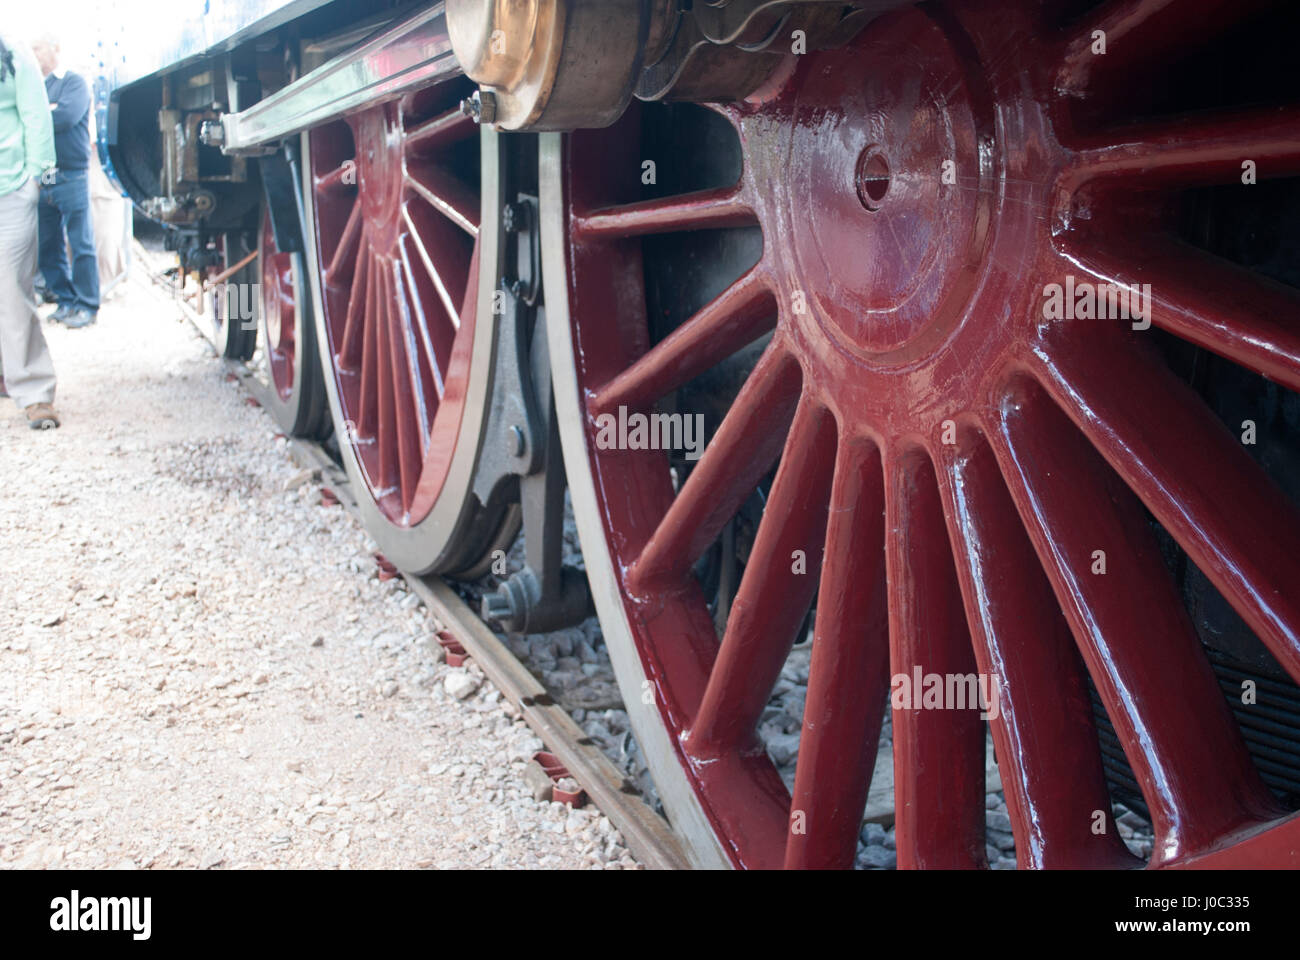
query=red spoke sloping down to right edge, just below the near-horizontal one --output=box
[1070,242,1300,390]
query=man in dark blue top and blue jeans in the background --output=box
[33,36,99,329]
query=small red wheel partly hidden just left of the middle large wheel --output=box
[257,215,330,438]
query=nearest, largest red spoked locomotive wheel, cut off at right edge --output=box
[541,0,1300,868]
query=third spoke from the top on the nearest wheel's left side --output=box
[628,342,800,592]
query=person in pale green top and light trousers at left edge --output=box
[0,35,59,429]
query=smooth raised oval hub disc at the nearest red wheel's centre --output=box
[784,12,987,360]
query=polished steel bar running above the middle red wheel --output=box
[220,3,460,153]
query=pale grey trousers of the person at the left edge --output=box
[0,180,55,407]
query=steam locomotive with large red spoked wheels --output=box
[107,0,1300,868]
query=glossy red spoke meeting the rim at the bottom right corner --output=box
[991,382,1273,864]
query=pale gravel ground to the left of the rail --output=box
[0,277,637,869]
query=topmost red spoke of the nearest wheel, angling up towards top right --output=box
[1057,0,1262,96]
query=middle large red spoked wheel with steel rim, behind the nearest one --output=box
[304,82,519,578]
